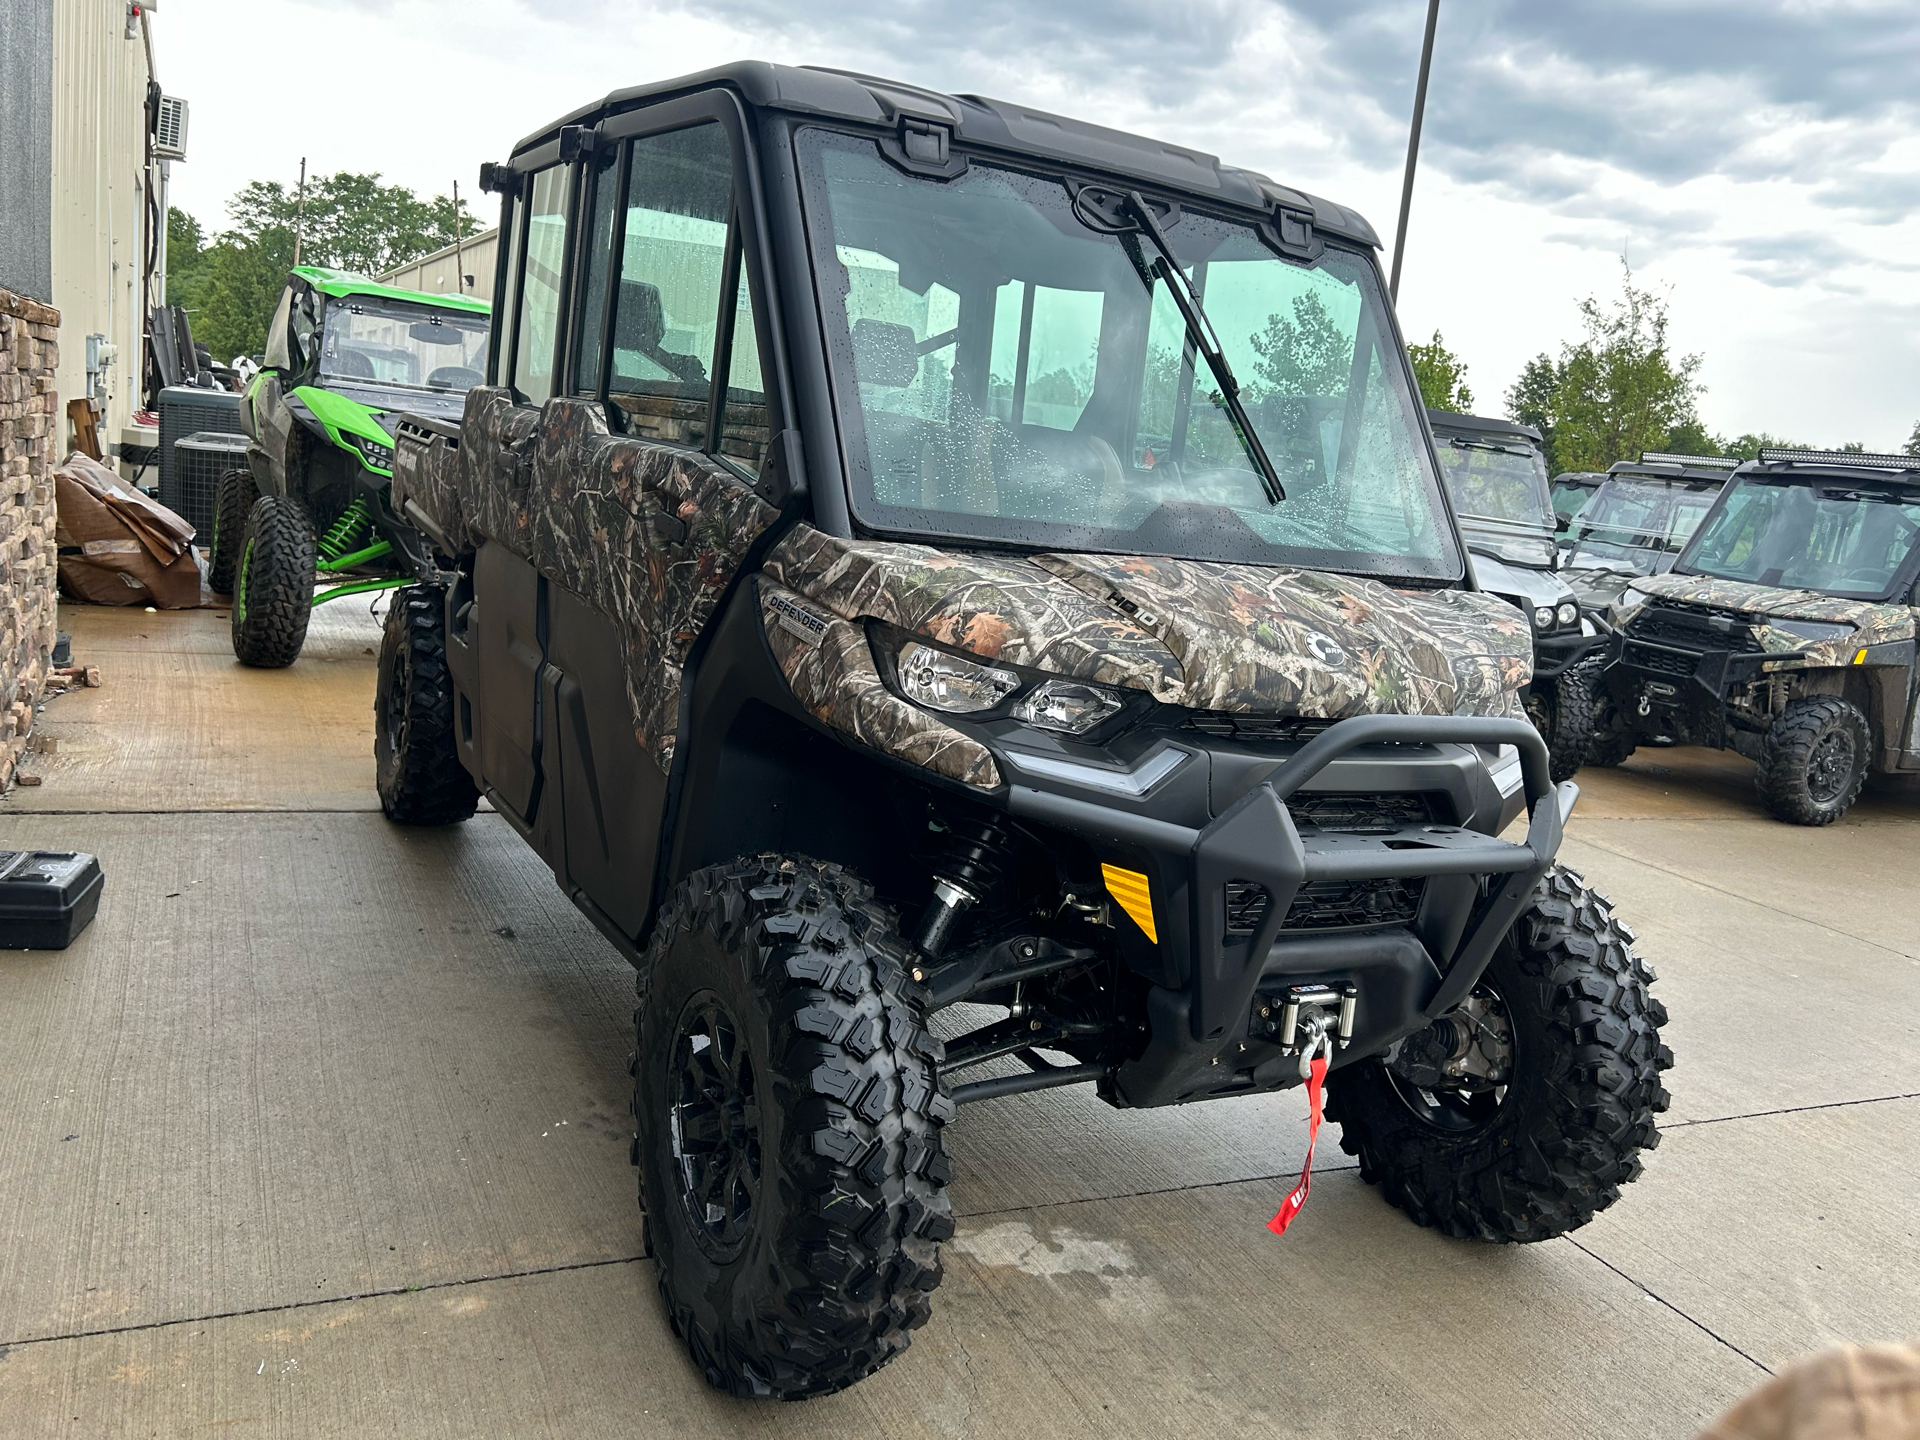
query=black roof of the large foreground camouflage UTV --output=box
[513,60,1380,248]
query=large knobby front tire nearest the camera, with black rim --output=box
[632,854,954,1400]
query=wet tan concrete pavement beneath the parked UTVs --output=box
[0,607,1920,1440]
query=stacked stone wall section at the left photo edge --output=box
[0,290,65,789]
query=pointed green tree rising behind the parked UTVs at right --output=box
[1507,261,1705,470]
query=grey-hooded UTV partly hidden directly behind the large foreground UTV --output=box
[1427,411,1607,781]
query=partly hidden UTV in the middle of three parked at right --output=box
[1559,451,1740,620]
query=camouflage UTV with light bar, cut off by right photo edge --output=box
[1592,449,1920,826]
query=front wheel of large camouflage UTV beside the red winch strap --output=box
[1327,866,1672,1242]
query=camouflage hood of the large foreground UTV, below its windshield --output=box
[766,526,1532,718]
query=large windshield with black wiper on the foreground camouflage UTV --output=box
[801,131,1461,580]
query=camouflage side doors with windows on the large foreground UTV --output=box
[463,96,778,935]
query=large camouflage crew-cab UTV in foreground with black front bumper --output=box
[374,63,1672,1398]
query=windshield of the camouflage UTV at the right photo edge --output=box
[1680,476,1920,599]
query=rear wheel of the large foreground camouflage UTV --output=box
[372,586,480,826]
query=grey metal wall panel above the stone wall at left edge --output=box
[0,0,54,305]
